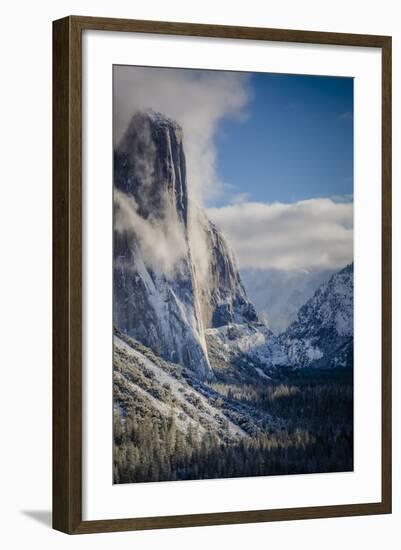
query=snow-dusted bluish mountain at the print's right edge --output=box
[280,264,354,368]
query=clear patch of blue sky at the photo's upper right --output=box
[213,73,353,206]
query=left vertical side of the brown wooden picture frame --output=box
[53,19,82,533]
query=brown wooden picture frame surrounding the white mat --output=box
[53,16,391,534]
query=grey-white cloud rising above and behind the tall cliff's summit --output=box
[114,66,250,204]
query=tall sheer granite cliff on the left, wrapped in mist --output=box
[113,111,257,378]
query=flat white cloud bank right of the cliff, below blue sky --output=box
[207,199,353,270]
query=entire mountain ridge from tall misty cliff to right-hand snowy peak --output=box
[113,111,353,380]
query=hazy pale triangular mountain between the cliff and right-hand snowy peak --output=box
[240,268,335,334]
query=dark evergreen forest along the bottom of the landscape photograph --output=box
[114,383,353,483]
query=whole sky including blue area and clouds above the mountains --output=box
[113,66,353,271]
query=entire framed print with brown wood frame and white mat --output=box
[53,16,391,534]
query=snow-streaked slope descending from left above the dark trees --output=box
[114,330,284,442]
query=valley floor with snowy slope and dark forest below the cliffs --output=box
[114,332,353,483]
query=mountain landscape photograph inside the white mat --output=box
[110,65,354,484]
